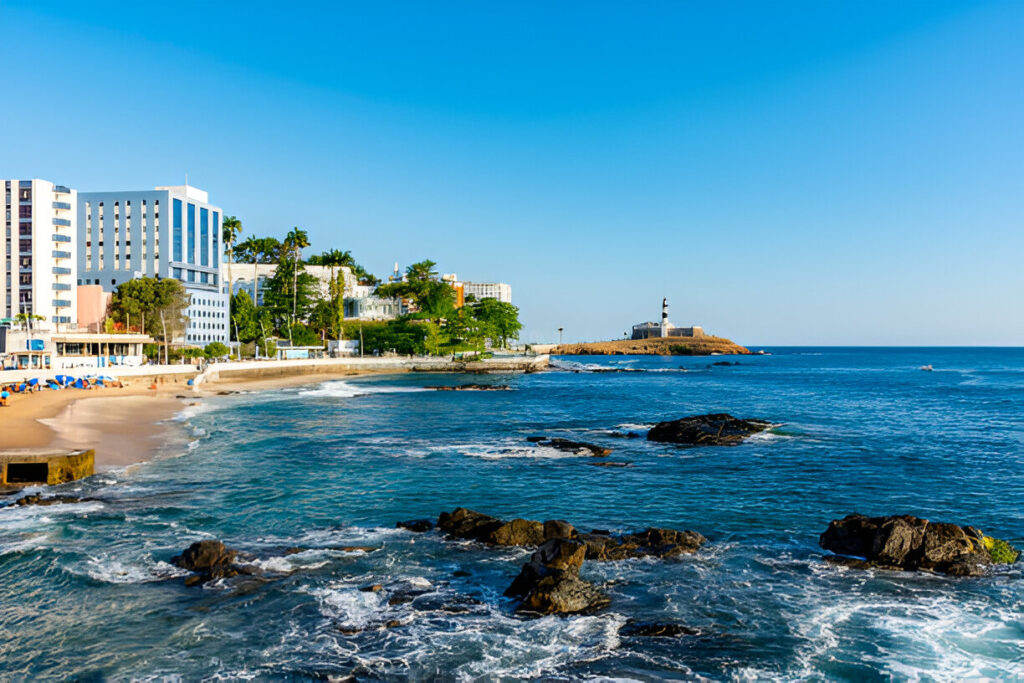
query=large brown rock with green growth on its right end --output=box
[819,514,1019,577]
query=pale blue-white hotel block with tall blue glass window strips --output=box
[78,185,229,346]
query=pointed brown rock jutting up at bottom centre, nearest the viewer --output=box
[505,539,611,614]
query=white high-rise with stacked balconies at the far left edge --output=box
[0,179,78,330]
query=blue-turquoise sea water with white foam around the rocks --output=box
[0,348,1024,680]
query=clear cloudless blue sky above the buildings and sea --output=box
[0,0,1024,345]
